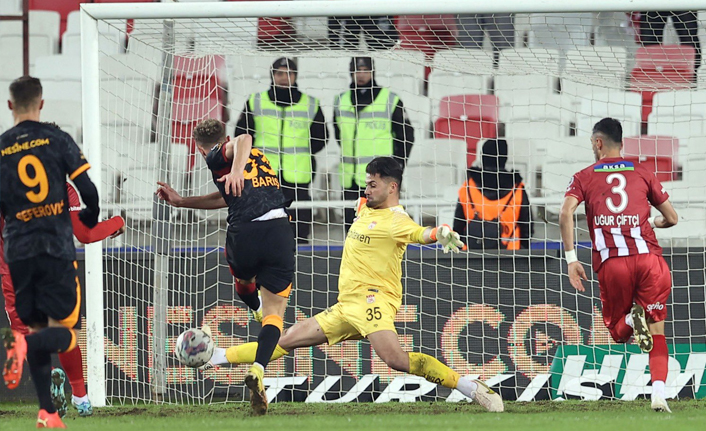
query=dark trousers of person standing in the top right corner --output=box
[640,11,701,69]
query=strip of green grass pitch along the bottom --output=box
[0,400,706,431]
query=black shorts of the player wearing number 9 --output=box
[9,255,81,329]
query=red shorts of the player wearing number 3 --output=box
[598,253,672,329]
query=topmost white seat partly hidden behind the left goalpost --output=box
[61,10,127,55]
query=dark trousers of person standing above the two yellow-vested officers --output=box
[328,16,398,49]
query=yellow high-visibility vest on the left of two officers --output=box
[248,91,319,184]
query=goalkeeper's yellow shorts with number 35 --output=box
[314,293,397,345]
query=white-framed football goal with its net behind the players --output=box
[77,0,706,405]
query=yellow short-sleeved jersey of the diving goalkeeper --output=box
[338,205,425,308]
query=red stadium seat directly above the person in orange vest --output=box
[434,94,498,166]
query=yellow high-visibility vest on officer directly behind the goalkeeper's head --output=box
[334,88,400,188]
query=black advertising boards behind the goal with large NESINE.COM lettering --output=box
[0,248,706,403]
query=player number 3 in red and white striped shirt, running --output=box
[559,118,677,411]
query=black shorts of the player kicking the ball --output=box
[226,218,296,293]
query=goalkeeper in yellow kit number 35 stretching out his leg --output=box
[204,157,504,412]
